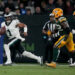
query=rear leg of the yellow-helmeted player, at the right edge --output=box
[66,33,75,66]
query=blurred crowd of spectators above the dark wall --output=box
[0,0,75,15]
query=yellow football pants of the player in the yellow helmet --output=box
[54,32,75,52]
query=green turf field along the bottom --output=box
[0,64,75,75]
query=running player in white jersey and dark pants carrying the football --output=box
[1,13,42,65]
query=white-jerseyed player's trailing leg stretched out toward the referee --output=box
[16,40,43,64]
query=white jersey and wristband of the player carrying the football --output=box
[1,15,24,41]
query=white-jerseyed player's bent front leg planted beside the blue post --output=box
[4,38,17,65]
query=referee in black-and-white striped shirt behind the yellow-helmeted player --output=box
[42,13,61,63]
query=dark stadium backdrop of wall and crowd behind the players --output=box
[0,0,75,63]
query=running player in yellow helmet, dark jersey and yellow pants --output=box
[46,8,75,68]
